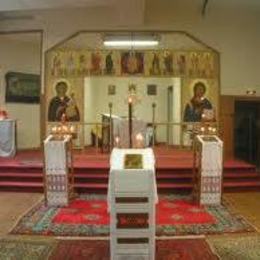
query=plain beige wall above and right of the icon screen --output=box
[0,0,260,96]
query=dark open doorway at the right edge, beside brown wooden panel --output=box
[234,101,260,167]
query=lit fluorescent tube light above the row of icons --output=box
[103,35,159,47]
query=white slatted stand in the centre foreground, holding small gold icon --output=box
[108,148,158,260]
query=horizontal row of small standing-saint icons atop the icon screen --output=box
[51,51,216,78]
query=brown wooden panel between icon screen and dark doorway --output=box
[220,96,235,159]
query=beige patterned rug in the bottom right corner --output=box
[208,235,260,260]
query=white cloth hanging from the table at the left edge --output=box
[0,119,16,157]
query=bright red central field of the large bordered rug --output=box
[52,199,216,225]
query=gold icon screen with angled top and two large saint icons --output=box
[45,32,220,147]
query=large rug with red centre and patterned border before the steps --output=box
[11,195,254,236]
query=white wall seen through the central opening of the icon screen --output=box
[84,77,181,144]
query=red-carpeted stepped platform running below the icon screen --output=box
[0,145,258,194]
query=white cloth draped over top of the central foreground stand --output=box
[107,148,158,211]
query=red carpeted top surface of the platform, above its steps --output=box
[0,147,252,169]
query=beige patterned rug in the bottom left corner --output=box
[0,238,56,260]
